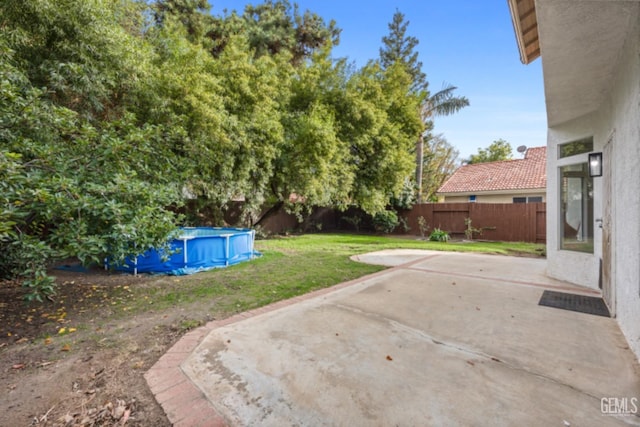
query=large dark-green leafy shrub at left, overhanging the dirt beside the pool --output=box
[0,61,181,301]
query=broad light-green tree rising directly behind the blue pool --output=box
[141,20,292,223]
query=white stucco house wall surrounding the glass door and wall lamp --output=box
[543,7,640,356]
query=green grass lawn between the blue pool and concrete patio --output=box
[136,234,544,315]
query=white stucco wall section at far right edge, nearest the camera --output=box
[598,11,640,357]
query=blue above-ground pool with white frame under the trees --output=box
[118,227,258,275]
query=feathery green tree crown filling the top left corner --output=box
[0,0,150,120]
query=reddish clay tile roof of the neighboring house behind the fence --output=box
[438,147,547,194]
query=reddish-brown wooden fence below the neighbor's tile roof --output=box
[400,203,547,243]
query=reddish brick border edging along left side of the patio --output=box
[144,264,400,427]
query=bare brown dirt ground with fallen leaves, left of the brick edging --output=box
[0,270,212,427]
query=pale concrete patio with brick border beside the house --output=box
[146,250,640,426]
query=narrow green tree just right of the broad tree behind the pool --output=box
[261,47,354,224]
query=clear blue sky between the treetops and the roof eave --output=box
[209,0,547,158]
